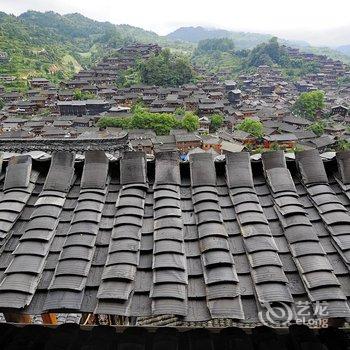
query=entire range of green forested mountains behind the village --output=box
[0,11,350,87]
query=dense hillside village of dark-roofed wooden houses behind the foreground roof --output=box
[0,44,350,159]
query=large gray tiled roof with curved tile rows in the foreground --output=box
[0,150,350,323]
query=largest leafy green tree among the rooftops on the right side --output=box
[292,90,325,120]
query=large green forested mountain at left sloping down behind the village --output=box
[0,11,166,86]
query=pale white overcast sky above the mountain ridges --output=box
[0,0,350,45]
